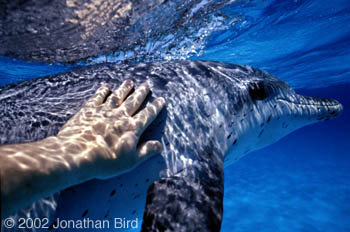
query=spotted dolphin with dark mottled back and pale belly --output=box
[0,61,342,231]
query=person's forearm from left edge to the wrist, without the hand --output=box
[0,137,88,216]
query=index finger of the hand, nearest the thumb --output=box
[134,97,165,136]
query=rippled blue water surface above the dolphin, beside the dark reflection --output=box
[0,0,350,88]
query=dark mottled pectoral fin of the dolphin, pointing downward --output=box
[141,151,224,231]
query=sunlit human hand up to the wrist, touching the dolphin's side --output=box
[57,81,165,179]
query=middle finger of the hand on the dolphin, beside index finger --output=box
[122,82,150,115]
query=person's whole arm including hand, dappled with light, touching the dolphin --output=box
[0,81,164,216]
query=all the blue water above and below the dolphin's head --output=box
[0,0,350,232]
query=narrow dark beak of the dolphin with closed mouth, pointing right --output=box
[277,95,343,117]
